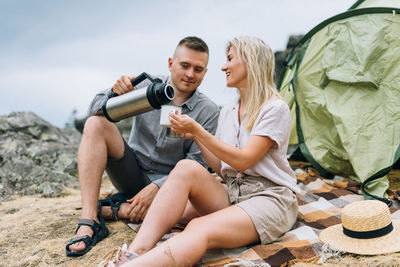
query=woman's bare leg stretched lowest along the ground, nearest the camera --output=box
[122,206,259,266]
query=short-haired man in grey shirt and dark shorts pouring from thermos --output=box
[66,36,219,256]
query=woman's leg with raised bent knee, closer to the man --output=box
[129,160,229,254]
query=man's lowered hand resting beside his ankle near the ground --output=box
[126,183,159,222]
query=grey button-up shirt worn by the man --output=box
[89,76,219,187]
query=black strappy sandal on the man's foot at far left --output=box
[65,216,108,257]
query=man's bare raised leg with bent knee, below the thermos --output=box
[69,116,124,251]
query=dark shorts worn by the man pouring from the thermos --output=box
[106,138,151,198]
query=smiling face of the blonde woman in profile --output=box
[221,47,248,88]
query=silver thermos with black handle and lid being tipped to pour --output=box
[96,72,175,122]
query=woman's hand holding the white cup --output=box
[169,112,202,139]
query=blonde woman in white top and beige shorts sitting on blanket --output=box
[112,37,298,266]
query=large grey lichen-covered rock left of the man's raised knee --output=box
[0,112,81,200]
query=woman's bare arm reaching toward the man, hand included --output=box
[170,113,274,172]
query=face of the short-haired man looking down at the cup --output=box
[168,46,208,96]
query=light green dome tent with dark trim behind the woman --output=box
[278,0,400,204]
